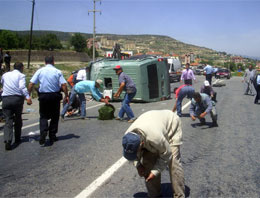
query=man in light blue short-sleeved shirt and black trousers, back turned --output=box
[28,56,68,145]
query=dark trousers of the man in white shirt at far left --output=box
[2,96,24,142]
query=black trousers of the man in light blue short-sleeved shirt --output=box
[39,93,62,138]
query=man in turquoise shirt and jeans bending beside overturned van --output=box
[61,79,109,119]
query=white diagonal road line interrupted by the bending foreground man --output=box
[75,79,219,198]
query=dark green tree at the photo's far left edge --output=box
[0,30,19,49]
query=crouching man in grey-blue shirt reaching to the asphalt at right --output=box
[190,92,218,127]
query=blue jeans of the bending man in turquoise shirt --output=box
[61,87,86,117]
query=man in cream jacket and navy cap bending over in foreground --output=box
[122,110,185,197]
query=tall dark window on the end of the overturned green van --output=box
[147,64,159,99]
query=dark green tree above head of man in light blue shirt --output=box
[41,34,62,51]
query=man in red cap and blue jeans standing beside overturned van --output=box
[114,65,136,123]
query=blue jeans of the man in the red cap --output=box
[118,91,136,119]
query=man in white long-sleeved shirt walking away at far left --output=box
[1,62,32,150]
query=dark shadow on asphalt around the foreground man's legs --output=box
[133,183,190,198]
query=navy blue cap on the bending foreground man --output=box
[122,132,141,161]
